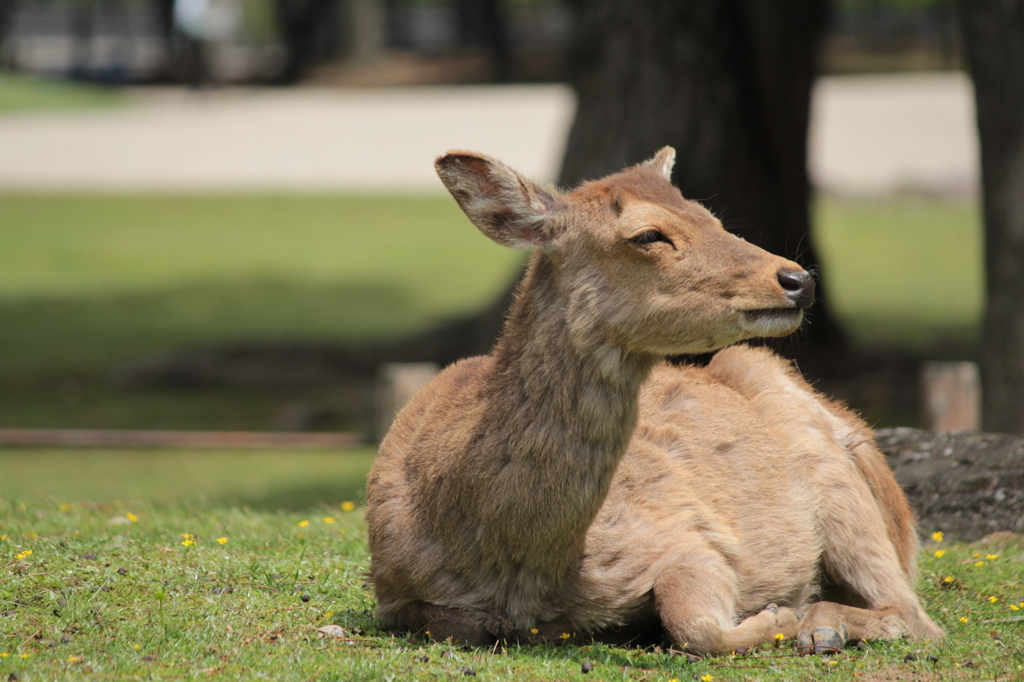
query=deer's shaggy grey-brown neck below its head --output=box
[480,254,654,574]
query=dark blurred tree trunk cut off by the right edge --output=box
[957,0,1024,433]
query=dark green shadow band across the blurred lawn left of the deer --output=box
[0,279,428,376]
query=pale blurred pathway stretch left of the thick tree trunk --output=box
[0,86,573,191]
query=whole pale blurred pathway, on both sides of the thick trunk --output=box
[0,74,977,194]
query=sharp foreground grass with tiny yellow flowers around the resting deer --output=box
[0,451,1024,682]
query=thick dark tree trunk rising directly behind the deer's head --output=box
[559,0,843,347]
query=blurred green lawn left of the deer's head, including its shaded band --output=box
[0,195,521,376]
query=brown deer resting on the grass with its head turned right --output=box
[367,147,942,654]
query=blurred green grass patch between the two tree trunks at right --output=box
[815,197,984,351]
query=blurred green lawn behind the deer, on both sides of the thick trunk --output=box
[0,188,982,429]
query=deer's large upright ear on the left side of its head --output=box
[434,152,560,249]
